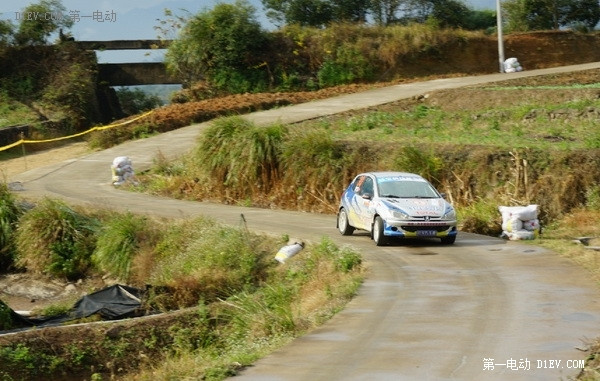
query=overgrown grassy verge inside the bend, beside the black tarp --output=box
[0,205,362,380]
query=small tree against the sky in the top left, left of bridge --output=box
[15,0,73,45]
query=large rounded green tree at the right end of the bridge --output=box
[166,0,268,92]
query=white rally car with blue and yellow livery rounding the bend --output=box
[337,172,458,246]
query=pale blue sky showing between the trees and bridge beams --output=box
[0,0,496,62]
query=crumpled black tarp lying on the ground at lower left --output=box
[0,284,144,329]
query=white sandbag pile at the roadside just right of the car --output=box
[498,205,540,241]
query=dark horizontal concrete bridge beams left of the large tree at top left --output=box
[73,40,181,86]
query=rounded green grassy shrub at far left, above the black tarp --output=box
[16,199,99,279]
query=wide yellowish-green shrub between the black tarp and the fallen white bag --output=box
[149,218,274,306]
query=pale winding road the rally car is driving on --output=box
[11,63,600,381]
